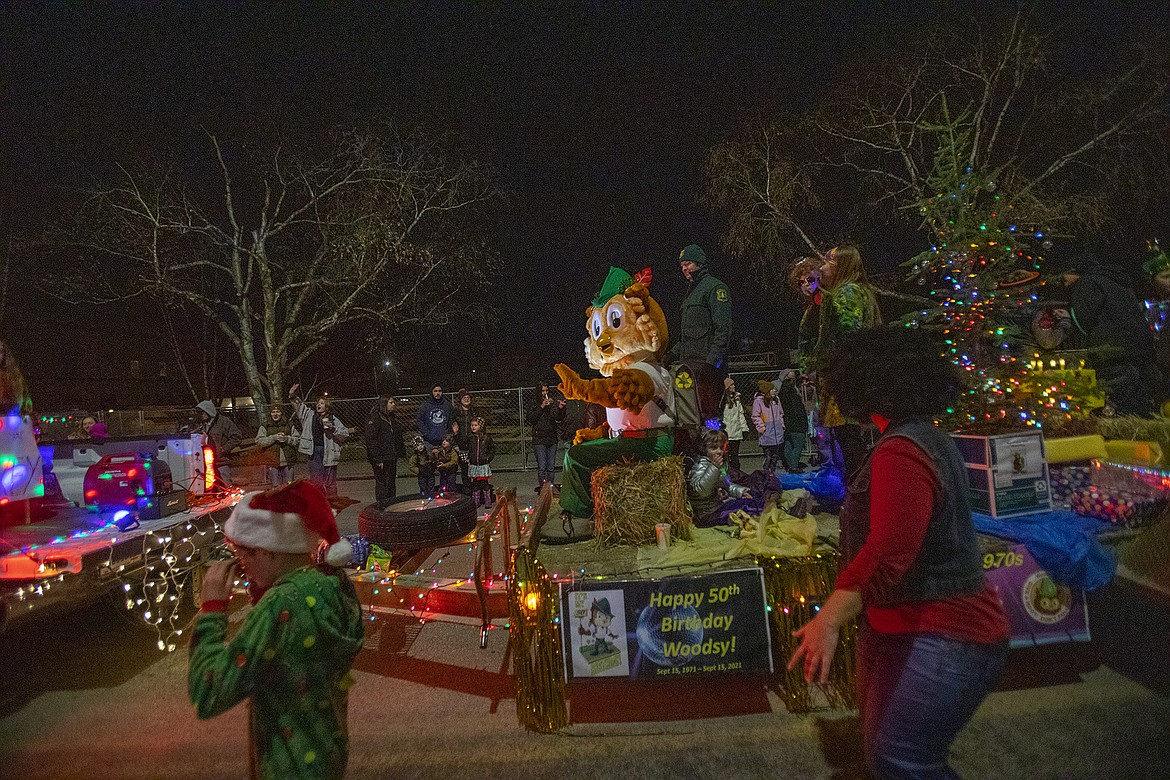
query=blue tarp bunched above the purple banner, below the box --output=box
[972,509,1117,591]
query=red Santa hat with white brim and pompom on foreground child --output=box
[223,479,353,566]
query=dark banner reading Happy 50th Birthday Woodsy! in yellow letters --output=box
[560,568,772,679]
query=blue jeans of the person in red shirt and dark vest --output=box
[858,620,1007,780]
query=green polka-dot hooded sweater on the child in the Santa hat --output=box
[187,567,363,778]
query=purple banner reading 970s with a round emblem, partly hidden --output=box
[979,536,1090,648]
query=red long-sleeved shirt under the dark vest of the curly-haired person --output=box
[837,436,1011,644]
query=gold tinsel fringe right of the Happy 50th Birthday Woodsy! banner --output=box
[756,552,858,712]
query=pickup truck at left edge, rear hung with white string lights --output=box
[0,426,239,630]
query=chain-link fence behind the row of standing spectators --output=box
[34,368,817,471]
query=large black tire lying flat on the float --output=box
[358,493,479,550]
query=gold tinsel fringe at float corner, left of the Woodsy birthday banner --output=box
[508,546,569,733]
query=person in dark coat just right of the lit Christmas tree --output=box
[1064,250,1162,416]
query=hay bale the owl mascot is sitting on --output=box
[591,455,693,546]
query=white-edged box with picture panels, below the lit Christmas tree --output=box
[951,430,1052,518]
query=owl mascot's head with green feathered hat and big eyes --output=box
[585,268,669,377]
